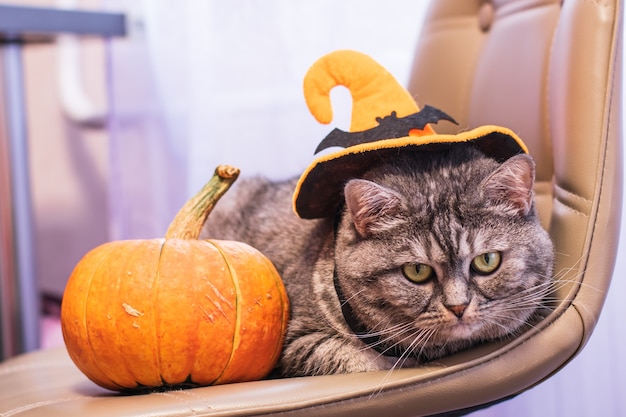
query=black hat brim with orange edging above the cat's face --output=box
[293,126,528,219]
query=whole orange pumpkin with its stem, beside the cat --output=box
[61,166,289,390]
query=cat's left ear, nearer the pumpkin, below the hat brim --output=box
[344,179,402,237]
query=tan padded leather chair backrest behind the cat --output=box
[409,0,622,364]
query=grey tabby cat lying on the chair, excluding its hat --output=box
[203,144,554,376]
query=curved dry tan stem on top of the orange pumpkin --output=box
[165,165,239,239]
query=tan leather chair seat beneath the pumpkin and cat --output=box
[0,309,583,417]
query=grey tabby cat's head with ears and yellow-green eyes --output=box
[336,149,553,358]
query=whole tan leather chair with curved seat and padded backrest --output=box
[0,0,622,417]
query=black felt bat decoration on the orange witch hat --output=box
[315,105,458,153]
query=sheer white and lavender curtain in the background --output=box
[108,0,626,417]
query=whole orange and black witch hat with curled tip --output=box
[293,50,528,219]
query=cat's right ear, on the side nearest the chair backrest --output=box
[482,154,535,216]
